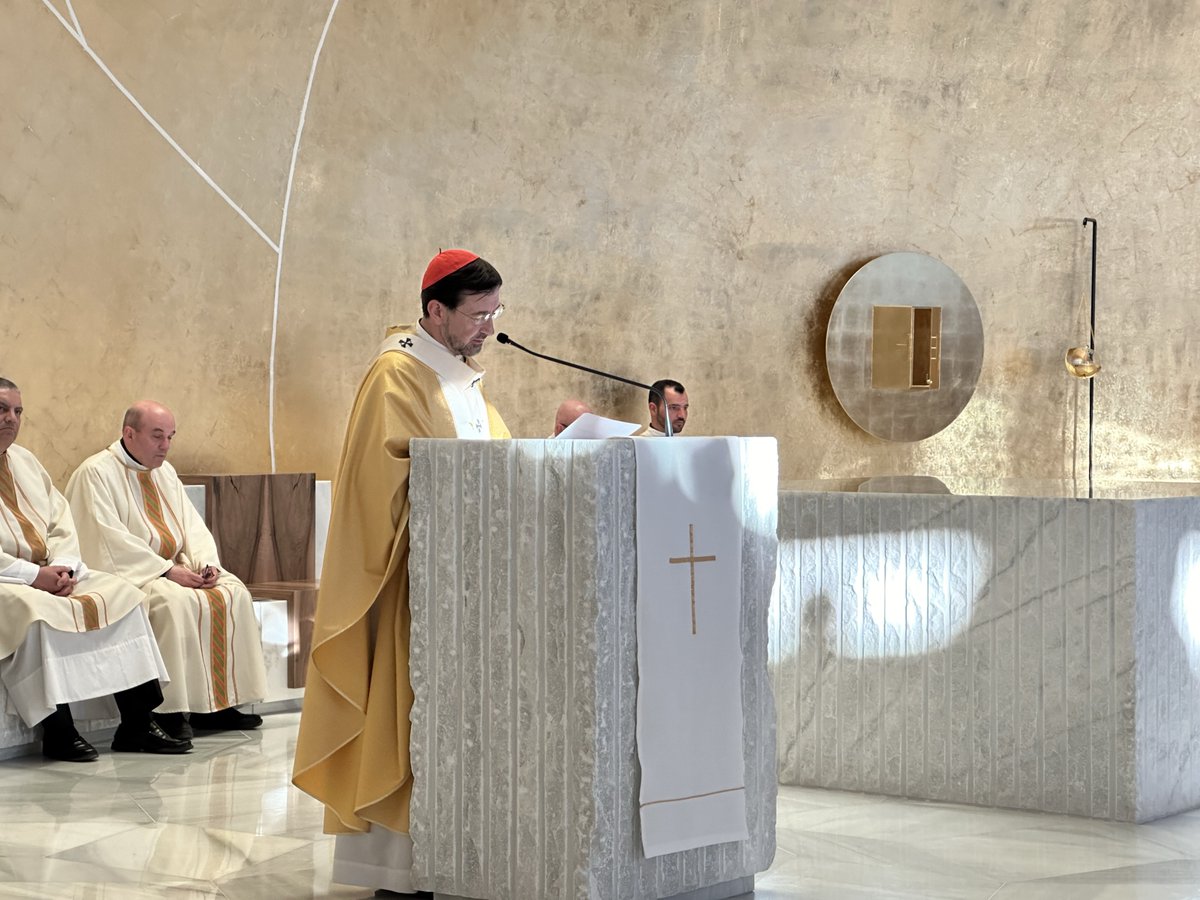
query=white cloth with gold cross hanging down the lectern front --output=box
[636,438,749,857]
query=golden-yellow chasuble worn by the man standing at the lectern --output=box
[293,325,510,834]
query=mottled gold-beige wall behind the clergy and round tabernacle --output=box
[0,0,1200,489]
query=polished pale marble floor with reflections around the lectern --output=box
[0,713,1200,900]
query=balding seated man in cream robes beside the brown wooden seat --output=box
[66,401,266,737]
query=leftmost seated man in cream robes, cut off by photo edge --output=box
[0,378,192,762]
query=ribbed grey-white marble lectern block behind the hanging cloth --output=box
[409,438,778,900]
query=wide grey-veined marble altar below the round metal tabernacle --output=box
[770,486,1200,822]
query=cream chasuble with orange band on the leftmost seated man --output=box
[0,444,144,659]
